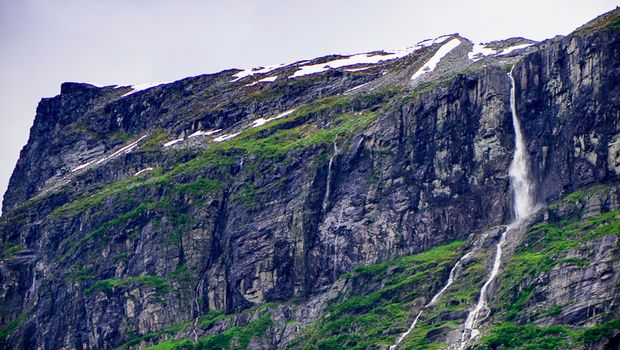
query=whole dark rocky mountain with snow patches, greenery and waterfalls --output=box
[0,9,620,349]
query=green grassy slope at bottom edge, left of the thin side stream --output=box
[291,241,464,349]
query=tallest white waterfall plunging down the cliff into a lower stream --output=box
[458,66,535,350]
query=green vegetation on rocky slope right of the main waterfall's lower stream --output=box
[479,185,620,350]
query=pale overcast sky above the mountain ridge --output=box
[0,0,620,211]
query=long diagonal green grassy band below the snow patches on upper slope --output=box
[50,91,388,221]
